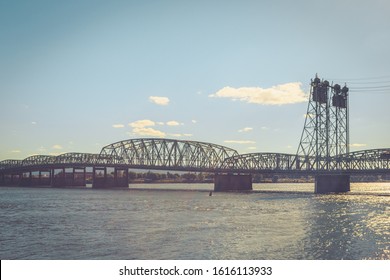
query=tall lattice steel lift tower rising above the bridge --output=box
[297,75,349,170]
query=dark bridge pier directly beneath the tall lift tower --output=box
[314,175,351,194]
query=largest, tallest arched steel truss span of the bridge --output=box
[100,138,238,171]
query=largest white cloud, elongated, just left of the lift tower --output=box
[209,82,307,105]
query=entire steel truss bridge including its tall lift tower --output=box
[0,76,390,189]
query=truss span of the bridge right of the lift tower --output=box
[336,148,390,171]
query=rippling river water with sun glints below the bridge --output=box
[0,183,390,260]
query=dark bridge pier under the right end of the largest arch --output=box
[214,174,252,192]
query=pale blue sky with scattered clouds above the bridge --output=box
[0,0,390,160]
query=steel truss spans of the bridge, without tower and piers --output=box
[0,138,390,174]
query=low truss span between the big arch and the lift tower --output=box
[222,153,305,171]
